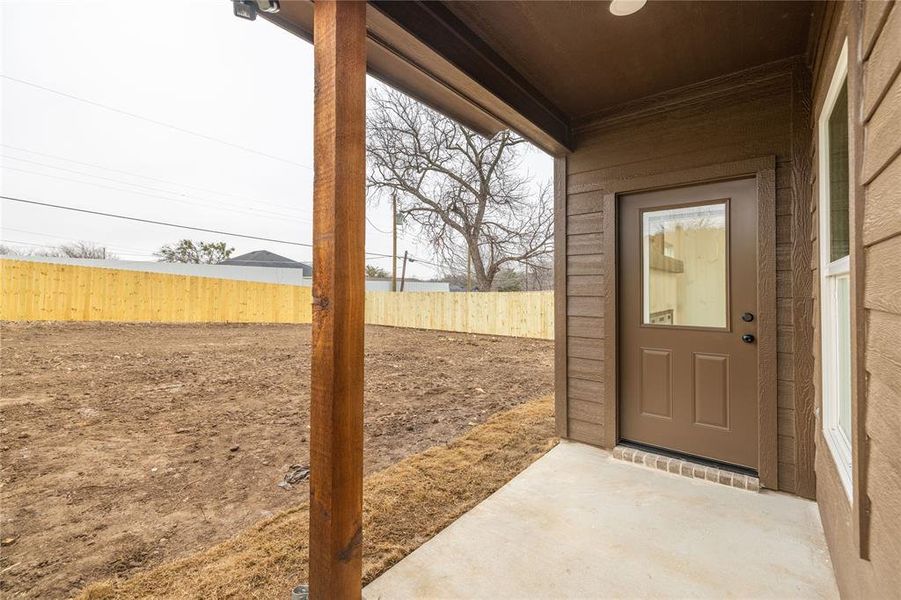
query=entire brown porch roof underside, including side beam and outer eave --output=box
[264,0,817,154]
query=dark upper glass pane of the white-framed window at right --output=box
[828,83,850,262]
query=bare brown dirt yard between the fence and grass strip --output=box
[0,323,553,597]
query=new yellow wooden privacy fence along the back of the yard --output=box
[0,259,554,339]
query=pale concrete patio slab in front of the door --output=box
[363,442,838,600]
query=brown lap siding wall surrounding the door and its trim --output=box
[558,61,813,495]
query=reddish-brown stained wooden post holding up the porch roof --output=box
[310,0,366,600]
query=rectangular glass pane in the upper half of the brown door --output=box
[642,202,728,327]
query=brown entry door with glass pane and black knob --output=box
[619,179,757,469]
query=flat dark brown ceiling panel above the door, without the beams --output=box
[445,0,813,122]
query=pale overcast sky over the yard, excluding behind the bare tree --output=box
[0,0,553,277]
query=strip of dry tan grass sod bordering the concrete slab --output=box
[80,398,556,600]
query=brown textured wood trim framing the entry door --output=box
[602,155,779,490]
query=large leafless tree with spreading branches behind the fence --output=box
[367,90,554,291]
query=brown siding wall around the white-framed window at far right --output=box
[811,2,901,598]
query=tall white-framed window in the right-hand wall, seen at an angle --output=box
[817,40,853,497]
